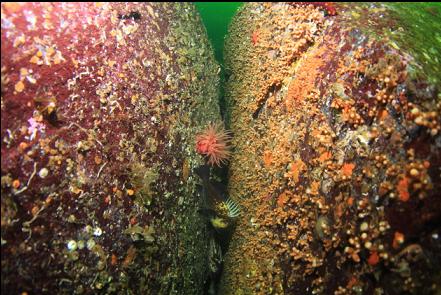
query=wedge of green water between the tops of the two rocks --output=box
[194,2,243,65]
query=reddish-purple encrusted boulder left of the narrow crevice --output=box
[1,3,219,294]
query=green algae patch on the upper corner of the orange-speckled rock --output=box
[340,2,441,84]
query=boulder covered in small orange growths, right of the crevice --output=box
[221,3,441,294]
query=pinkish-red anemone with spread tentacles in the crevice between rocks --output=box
[196,124,231,166]
